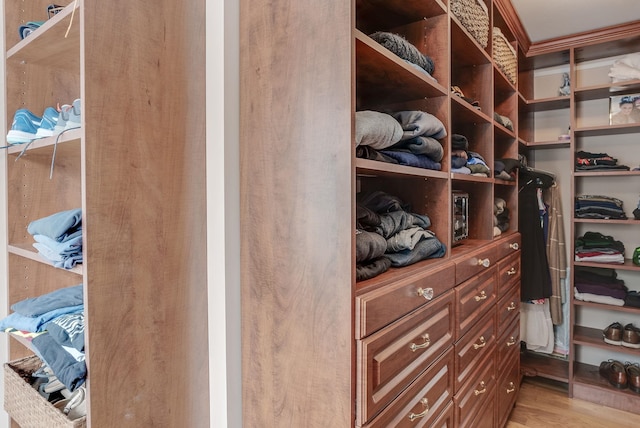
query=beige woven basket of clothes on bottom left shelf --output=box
[4,355,87,428]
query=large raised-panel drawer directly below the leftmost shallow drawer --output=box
[356,290,455,424]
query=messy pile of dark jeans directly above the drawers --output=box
[356,191,446,281]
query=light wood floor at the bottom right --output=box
[506,378,640,428]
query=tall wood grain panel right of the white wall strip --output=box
[240,0,354,428]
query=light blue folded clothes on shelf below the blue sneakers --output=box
[27,208,82,269]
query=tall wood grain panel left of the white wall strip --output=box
[81,0,209,427]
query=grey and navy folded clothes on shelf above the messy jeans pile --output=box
[355,110,447,170]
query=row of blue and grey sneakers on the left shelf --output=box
[7,98,81,145]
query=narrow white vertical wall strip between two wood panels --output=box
[206,0,242,428]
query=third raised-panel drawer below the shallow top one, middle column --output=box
[453,349,496,427]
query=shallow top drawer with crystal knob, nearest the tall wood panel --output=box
[355,263,455,339]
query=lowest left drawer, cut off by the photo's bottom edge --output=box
[365,348,453,428]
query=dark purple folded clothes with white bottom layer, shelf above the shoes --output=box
[574,266,629,306]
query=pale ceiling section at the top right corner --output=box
[511,0,640,43]
